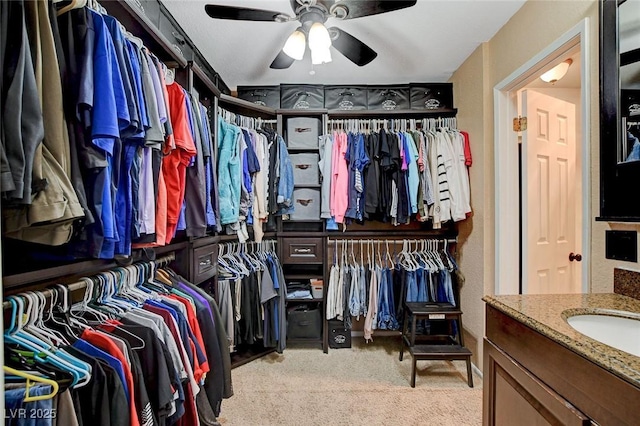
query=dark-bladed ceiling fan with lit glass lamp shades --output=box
[205,0,417,69]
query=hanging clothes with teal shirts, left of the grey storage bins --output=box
[217,107,293,243]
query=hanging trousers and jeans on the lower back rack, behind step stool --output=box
[326,238,458,341]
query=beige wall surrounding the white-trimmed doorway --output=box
[444,0,640,368]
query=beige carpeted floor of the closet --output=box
[218,337,482,426]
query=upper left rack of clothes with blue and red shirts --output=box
[1,0,222,259]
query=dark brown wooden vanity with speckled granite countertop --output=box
[483,294,640,425]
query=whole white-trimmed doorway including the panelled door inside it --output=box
[494,19,590,294]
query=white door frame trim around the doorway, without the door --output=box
[493,18,591,294]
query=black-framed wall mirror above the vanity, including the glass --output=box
[598,0,640,222]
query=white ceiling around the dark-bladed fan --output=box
[162,0,525,90]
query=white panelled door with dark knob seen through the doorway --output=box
[522,90,582,294]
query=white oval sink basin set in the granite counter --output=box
[567,311,640,357]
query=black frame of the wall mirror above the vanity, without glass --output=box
[596,0,640,222]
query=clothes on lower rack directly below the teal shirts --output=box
[217,240,286,365]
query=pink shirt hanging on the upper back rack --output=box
[330,132,349,223]
